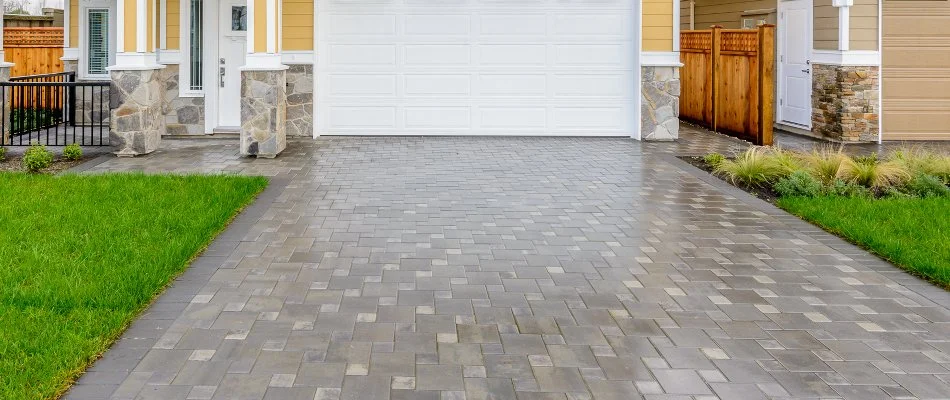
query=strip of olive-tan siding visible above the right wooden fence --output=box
[680,0,776,30]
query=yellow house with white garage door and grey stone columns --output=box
[24,0,692,156]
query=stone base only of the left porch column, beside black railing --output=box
[109,69,165,157]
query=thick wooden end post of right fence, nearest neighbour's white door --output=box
[756,25,775,146]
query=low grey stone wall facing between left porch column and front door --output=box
[161,64,205,135]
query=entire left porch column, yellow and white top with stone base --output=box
[108,0,165,157]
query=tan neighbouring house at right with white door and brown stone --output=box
[680,0,950,142]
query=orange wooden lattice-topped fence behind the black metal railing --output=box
[3,27,63,76]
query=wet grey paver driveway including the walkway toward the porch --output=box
[66,130,950,400]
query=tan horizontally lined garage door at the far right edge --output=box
[882,1,950,140]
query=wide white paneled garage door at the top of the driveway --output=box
[315,0,639,136]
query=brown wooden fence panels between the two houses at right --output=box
[680,25,775,145]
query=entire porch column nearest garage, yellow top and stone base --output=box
[241,0,288,158]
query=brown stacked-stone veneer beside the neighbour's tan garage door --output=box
[812,64,880,142]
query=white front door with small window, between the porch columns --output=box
[216,0,247,128]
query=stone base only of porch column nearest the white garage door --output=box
[241,68,287,158]
